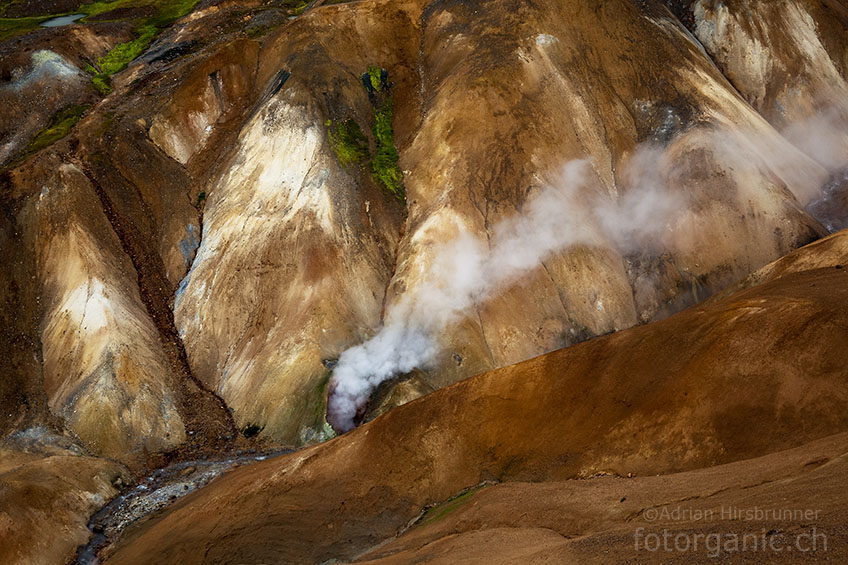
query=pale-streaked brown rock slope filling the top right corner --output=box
[692,0,848,133]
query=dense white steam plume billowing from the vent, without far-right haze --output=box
[327,155,683,431]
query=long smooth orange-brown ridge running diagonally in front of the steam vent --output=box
[106,236,848,563]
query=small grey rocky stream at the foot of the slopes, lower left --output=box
[76,450,284,565]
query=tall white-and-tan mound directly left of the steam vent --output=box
[175,0,415,443]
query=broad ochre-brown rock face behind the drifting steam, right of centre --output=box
[393,2,825,378]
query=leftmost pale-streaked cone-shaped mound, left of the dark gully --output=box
[36,165,185,461]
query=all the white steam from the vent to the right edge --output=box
[327,115,848,432]
